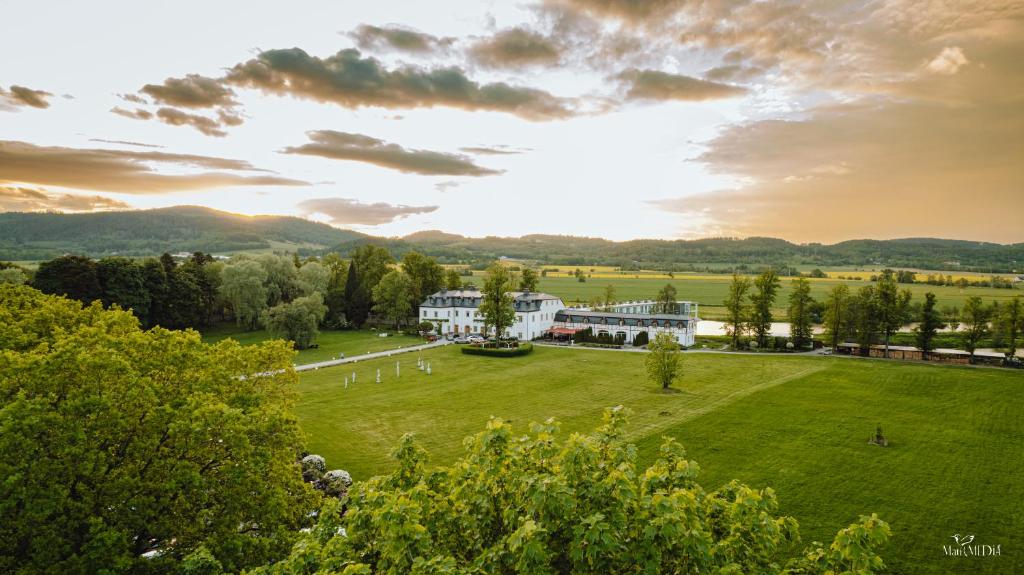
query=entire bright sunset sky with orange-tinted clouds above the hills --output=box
[0,0,1024,244]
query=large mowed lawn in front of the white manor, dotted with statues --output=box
[297,346,1024,573]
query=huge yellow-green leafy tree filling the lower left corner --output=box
[0,285,315,573]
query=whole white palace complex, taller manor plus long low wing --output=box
[420,290,699,347]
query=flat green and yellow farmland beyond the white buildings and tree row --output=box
[532,274,1024,319]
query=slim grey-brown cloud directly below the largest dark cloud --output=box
[284,130,501,176]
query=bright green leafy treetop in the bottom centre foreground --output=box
[254,407,890,575]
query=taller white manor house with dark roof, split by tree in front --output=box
[420,290,565,340]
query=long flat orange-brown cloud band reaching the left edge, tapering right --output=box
[0,141,308,194]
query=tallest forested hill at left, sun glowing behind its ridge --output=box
[0,206,366,260]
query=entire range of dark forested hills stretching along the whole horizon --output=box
[0,206,1024,273]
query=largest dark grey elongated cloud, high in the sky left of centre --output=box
[225,48,573,121]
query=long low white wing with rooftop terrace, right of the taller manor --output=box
[551,301,699,347]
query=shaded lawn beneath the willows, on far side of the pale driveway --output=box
[203,323,424,364]
